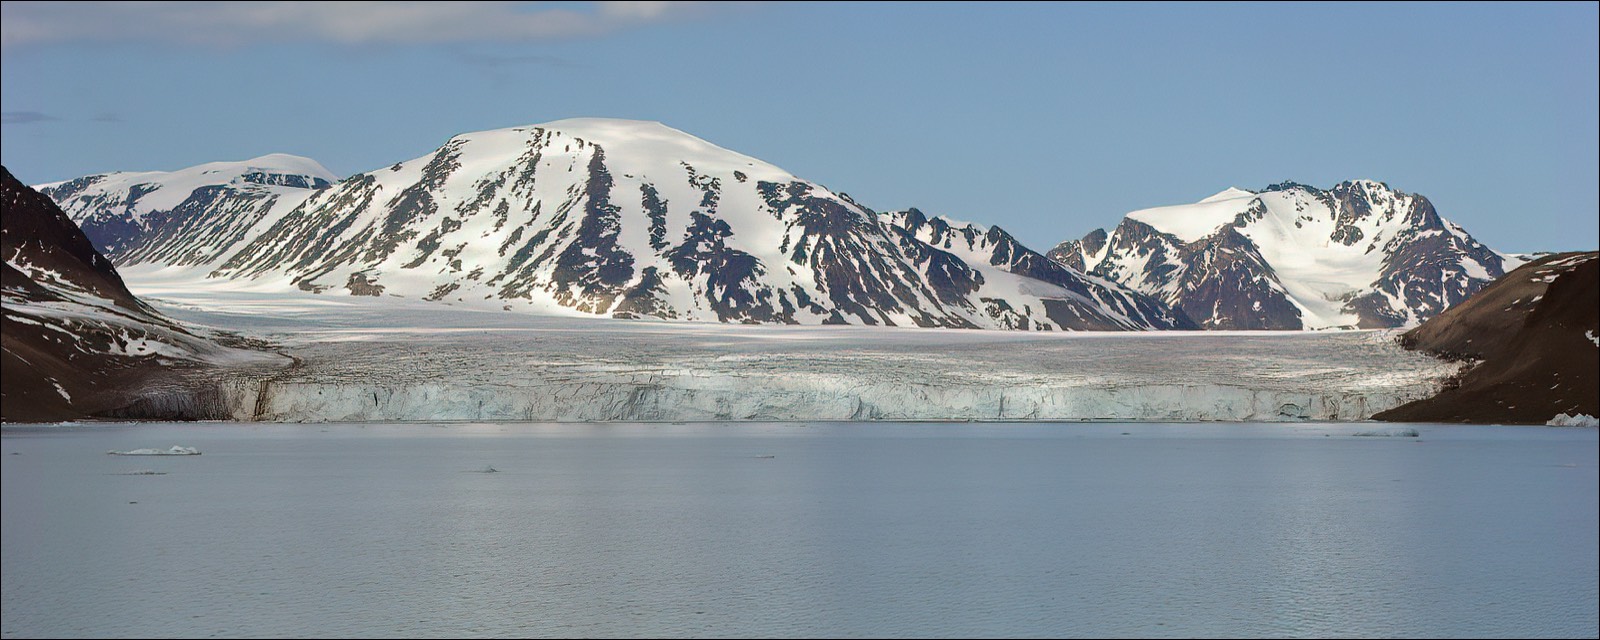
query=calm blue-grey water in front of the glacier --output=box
[0,424,1600,638]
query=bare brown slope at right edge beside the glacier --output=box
[1374,253,1600,424]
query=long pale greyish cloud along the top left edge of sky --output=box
[0,2,710,48]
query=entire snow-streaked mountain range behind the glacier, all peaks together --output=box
[40,118,1520,330]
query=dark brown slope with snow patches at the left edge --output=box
[0,168,278,421]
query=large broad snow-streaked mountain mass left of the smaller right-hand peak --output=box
[45,118,1192,330]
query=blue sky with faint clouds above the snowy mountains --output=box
[0,2,1600,251]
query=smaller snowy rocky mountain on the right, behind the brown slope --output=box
[1050,181,1520,330]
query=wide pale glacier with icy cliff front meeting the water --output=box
[123,266,1459,422]
